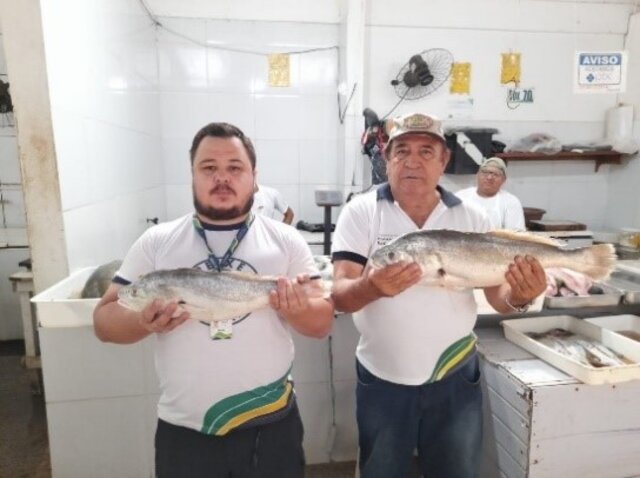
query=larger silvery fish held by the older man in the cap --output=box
[369,229,616,289]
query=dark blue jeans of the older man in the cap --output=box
[356,354,482,478]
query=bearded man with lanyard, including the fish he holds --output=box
[94,123,333,478]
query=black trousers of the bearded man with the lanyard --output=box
[155,405,304,478]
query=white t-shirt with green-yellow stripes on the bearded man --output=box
[116,215,317,435]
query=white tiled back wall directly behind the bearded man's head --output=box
[158,18,339,222]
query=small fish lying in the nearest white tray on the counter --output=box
[527,328,633,368]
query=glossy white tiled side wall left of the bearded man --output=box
[41,0,166,270]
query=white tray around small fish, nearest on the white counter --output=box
[502,315,640,385]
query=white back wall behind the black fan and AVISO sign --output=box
[366,0,640,230]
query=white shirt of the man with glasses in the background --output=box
[456,186,525,231]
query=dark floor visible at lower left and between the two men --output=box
[0,341,368,478]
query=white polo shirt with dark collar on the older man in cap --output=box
[332,184,489,385]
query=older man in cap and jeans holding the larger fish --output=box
[332,114,546,478]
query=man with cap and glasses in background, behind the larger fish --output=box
[456,157,525,231]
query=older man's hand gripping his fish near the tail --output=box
[505,256,547,307]
